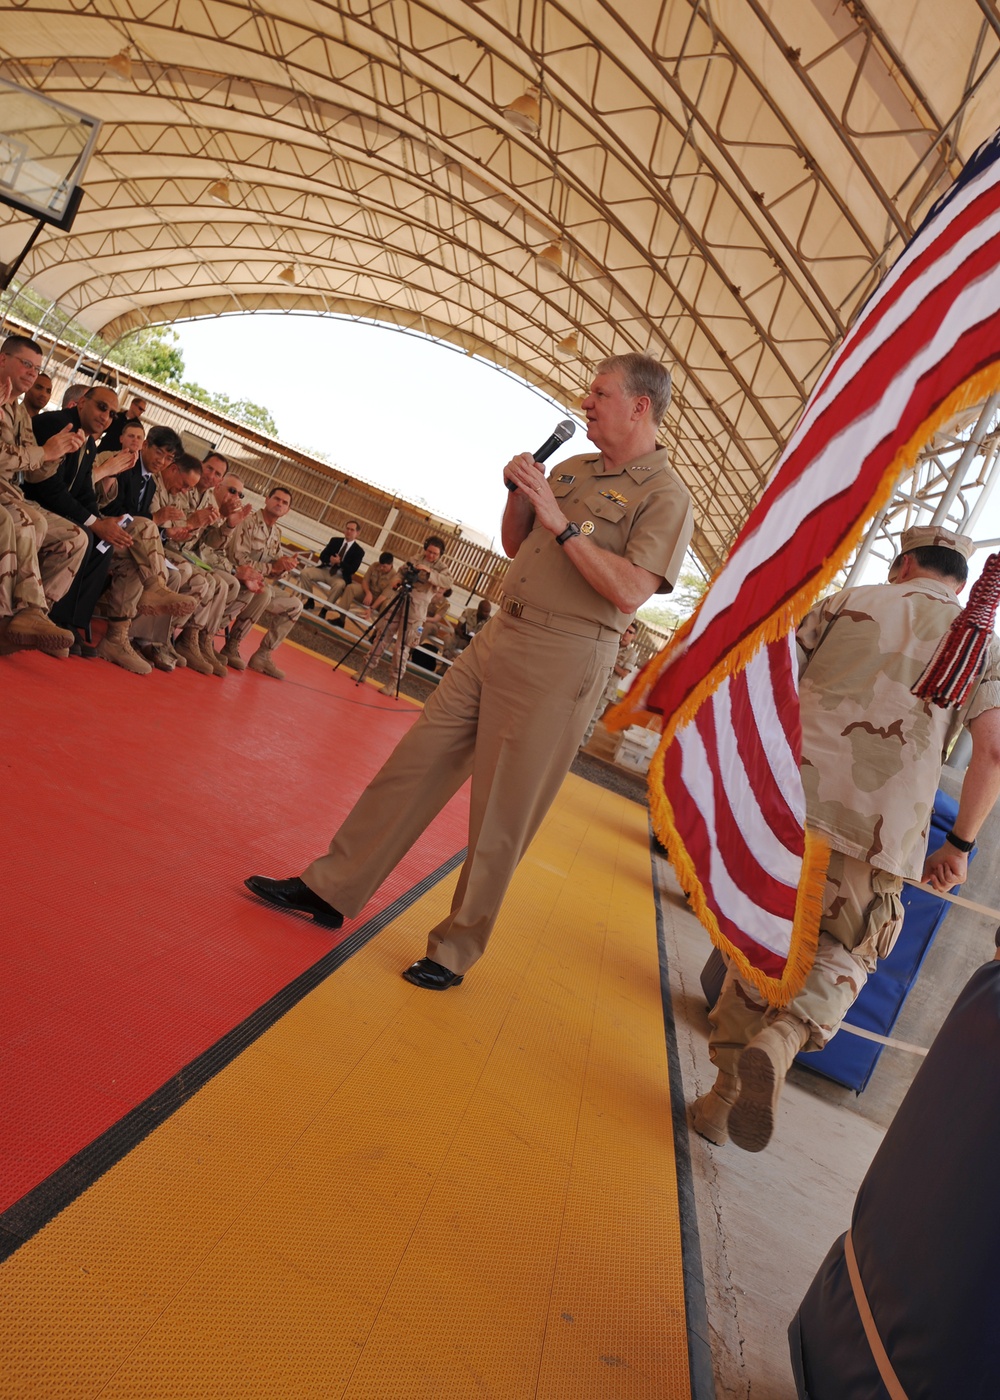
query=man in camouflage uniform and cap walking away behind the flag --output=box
[692,526,1000,1152]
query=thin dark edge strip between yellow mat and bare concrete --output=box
[650,827,716,1400]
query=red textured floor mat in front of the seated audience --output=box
[0,647,468,1211]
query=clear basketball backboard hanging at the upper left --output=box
[0,78,101,228]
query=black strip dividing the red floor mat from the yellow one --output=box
[0,850,465,1263]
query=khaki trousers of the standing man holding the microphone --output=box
[303,613,618,973]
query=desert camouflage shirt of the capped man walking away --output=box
[797,578,1000,879]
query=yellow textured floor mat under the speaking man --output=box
[0,777,690,1400]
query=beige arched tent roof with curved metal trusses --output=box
[0,0,1000,566]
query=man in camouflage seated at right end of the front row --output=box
[223,486,303,680]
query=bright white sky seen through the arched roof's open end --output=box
[175,315,585,539]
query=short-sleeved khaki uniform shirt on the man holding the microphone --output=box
[503,448,693,633]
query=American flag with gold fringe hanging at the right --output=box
[615,132,1000,1005]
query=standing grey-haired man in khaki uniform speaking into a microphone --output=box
[246,354,692,990]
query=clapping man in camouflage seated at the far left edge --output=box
[0,336,90,655]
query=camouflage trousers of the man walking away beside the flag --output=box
[709,851,903,1074]
